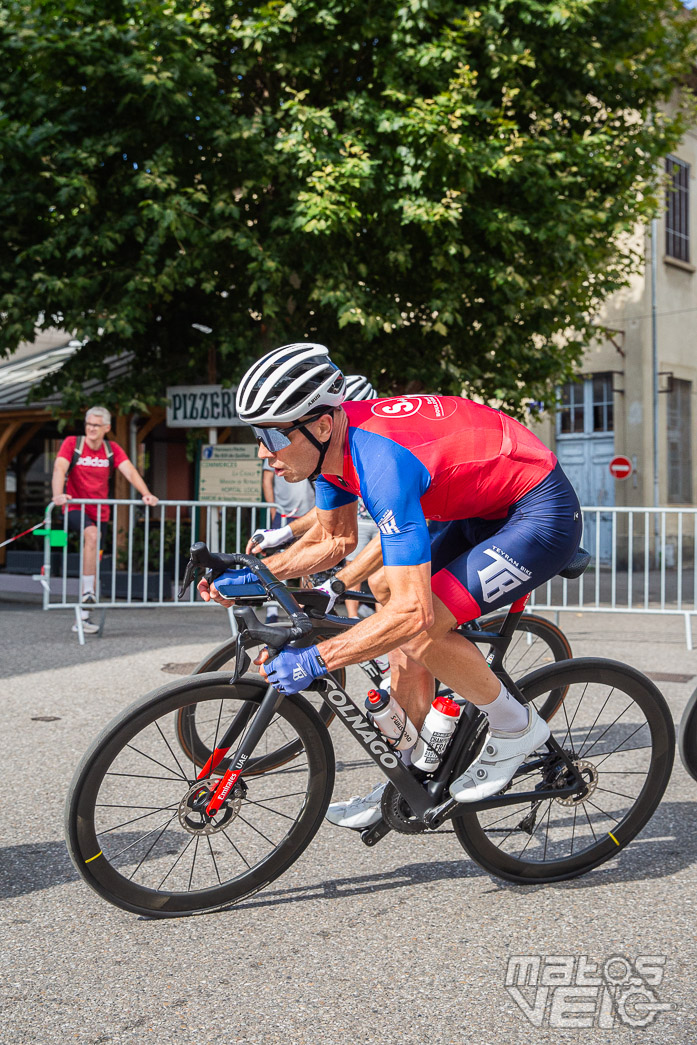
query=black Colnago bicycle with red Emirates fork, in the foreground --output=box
[66,545,675,918]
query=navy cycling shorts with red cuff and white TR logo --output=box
[431,464,582,624]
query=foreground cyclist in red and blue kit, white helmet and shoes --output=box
[200,343,581,829]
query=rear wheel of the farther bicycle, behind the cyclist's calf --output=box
[482,613,574,722]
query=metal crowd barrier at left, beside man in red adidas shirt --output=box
[38,498,277,643]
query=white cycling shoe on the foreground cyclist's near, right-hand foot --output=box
[450,704,550,802]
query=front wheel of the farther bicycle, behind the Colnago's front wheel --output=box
[177,638,346,776]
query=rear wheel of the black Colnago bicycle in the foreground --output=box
[452,657,675,883]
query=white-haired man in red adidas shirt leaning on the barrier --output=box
[51,407,158,634]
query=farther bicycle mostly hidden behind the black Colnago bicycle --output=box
[171,593,568,775]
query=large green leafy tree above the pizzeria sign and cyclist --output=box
[0,0,694,413]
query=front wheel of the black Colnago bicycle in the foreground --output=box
[66,673,334,918]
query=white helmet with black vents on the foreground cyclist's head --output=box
[236,342,346,425]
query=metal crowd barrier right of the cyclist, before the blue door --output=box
[530,506,697,650]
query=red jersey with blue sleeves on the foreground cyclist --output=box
[316,395,557,565]
